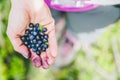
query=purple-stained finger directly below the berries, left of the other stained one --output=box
[30,49,41,67]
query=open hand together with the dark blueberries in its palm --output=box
[7,0,57,69]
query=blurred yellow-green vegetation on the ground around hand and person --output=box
[0,0,120,80]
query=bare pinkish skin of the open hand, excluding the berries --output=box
[7,0,57,69]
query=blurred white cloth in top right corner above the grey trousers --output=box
[86,0,120,5]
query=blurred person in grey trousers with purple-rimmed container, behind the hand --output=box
[45,0,120,68]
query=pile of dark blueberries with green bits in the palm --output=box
[20,23,48,55]
